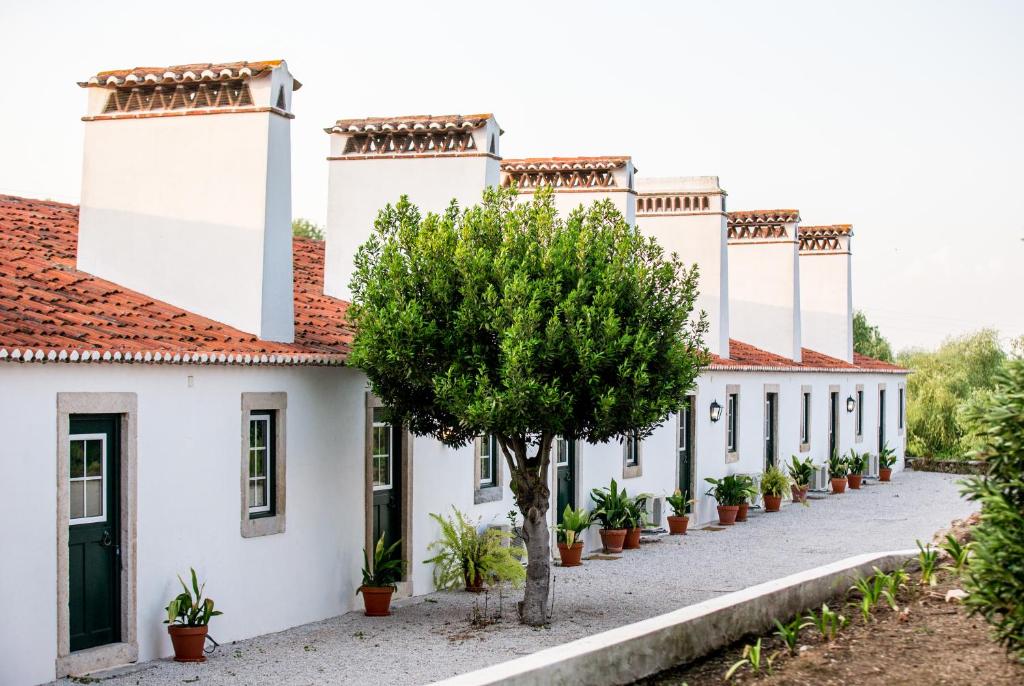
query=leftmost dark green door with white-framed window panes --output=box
[68,415,121,650]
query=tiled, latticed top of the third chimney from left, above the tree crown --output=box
[502,156,637,190]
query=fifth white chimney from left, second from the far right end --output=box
[728,210,802,361]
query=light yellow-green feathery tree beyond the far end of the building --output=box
[899,329,1007,458]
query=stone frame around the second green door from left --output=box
[362,391,413,598]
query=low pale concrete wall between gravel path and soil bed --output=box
[435,550,918,686]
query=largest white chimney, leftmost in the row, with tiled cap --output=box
[78,60,301,342]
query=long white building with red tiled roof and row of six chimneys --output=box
[0,61,905,684]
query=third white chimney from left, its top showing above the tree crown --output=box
[502,156,637,224]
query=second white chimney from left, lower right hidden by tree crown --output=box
[324,114,502,300]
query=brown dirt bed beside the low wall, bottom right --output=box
[638,528,1024,686]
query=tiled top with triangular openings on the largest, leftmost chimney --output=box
[78,59,302,121]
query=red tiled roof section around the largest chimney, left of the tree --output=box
[0,196,352,363]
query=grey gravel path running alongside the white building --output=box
[60,472,974,686]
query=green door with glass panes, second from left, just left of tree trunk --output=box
[370,408,402,546]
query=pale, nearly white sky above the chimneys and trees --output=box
[0,0,1024,349]
